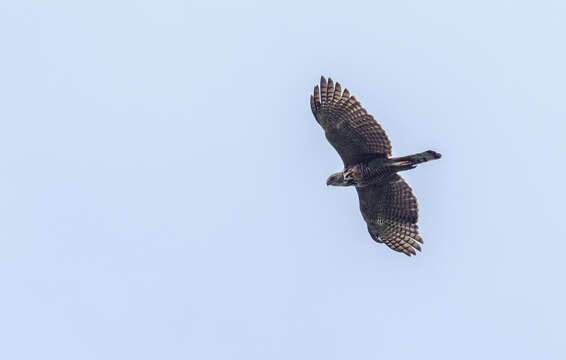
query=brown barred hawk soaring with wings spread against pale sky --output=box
[311,77,441,256]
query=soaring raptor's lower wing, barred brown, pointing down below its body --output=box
[356,175,423,256]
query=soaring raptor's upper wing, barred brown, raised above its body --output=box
[311,77,391,166]
